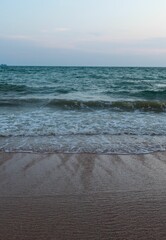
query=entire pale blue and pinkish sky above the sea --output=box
[0,0,166,67]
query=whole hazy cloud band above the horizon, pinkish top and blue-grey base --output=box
[0,34,166,66]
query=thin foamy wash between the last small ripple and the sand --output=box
[0,134,166,155]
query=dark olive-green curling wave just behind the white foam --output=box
[0,98,166,112]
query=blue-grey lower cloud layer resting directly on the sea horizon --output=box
[0,37,166,66]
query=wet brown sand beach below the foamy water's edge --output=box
[0,152,166,240]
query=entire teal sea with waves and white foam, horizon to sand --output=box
[0,66,166,154]
